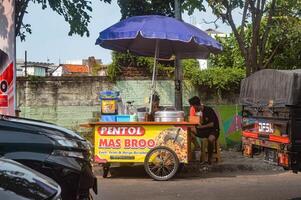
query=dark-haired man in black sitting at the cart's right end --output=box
[189,96,220,164]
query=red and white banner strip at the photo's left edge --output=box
[0,0,16,115]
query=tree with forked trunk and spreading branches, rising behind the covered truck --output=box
[207,0,301,75]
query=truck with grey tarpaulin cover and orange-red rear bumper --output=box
[240,69,301,173]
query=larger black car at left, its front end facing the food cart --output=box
[0,116,97,200]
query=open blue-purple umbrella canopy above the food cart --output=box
[96,15,222,58]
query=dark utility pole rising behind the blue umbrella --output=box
[174,0,183,110]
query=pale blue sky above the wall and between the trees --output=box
[16,0,239,64]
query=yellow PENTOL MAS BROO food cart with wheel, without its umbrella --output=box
[81,121,197,180]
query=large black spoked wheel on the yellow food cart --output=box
[144,147,179,181]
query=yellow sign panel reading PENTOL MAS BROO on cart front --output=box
[94,125,188,163]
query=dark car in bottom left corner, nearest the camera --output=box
[0,158,61,200]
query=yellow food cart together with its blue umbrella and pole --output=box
[86,15,222,180]
